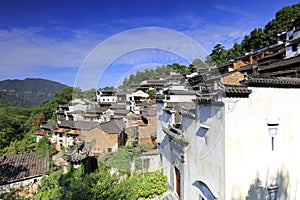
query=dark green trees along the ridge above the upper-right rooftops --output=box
[210,3,300,65]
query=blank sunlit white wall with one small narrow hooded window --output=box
[224,88,300,200]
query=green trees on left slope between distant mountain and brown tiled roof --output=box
[0,101,58,155]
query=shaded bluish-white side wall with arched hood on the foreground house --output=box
[184,104,225,199]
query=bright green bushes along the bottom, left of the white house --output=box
[33,163,168,200]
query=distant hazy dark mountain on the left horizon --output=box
[0,78,66,104]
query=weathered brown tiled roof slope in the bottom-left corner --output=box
[0,152,49,185]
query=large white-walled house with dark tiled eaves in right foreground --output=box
[157,78,300,200]
